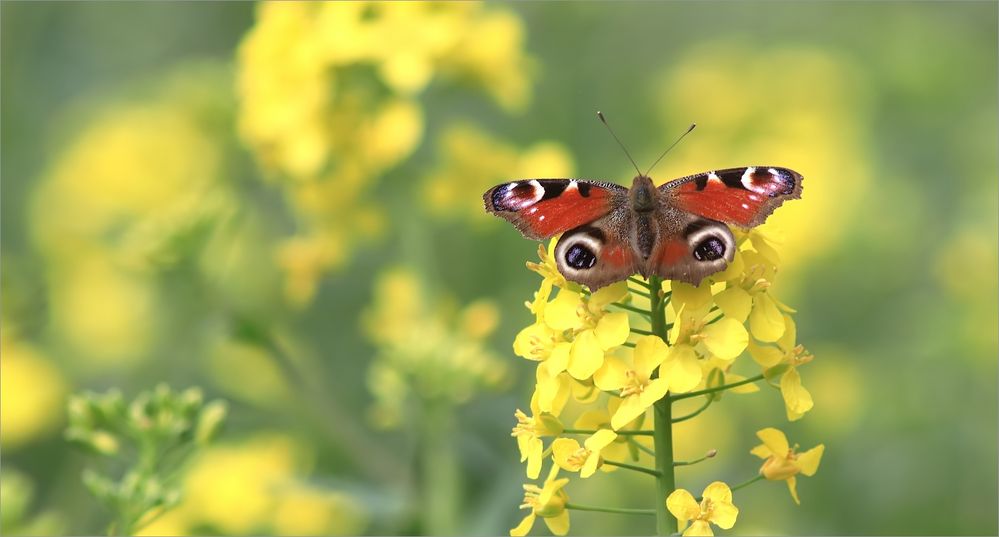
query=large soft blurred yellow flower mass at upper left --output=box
[31,61,234,365]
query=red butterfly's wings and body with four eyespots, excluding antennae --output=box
[483,166,802,290]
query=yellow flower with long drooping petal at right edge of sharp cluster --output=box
[749,315,814,421]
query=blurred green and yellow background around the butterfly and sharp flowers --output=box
[0,2,999,535]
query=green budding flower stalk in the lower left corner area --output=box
[65,384,227,535]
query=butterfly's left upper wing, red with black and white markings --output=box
[482,179,628,240]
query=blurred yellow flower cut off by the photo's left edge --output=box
[0,338,66,450]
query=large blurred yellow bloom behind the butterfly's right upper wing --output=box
[659,43,872,276]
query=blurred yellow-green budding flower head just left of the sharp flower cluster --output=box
[362,268,507,427]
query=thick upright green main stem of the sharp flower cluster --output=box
[649,276,677,535]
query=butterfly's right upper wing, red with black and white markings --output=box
[659,166,802,227]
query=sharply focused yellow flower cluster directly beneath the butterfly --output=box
[511,226,822,535]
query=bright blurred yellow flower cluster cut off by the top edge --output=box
[237,2,531,304]
